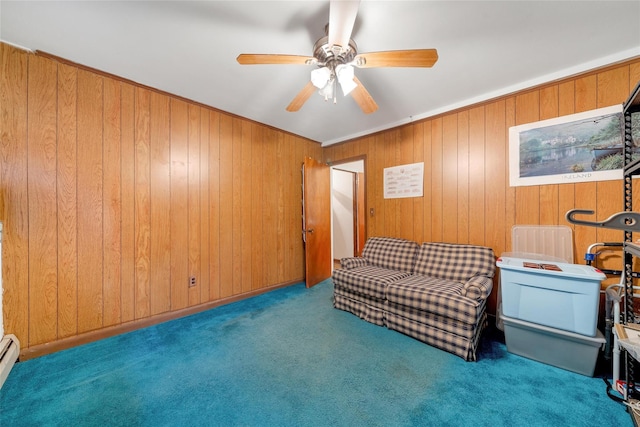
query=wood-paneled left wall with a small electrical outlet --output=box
[0,44,322,348]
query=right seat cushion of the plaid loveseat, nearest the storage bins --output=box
[387,274,484,325]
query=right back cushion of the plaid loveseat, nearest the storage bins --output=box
[414,243,496,283]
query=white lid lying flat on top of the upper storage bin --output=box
[496,257,607,281]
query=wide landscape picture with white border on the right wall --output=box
[509,105,624,187]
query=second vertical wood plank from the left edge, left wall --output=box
[27,56,58,345]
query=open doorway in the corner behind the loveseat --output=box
[331,159,365,269]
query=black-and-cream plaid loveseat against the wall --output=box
[332,237,496,360]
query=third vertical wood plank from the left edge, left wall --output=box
[57,64,78,338]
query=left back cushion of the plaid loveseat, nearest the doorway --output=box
[362,237,420,273]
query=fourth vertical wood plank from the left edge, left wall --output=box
[78,70,104,333]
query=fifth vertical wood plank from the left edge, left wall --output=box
[102,78,122,326]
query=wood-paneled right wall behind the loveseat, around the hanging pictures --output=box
[324,60,640,313]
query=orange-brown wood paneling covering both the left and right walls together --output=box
[0,43,640,354]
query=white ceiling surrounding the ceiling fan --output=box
[0,0,640,145]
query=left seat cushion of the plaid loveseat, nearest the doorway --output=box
[333,265,410,300]
